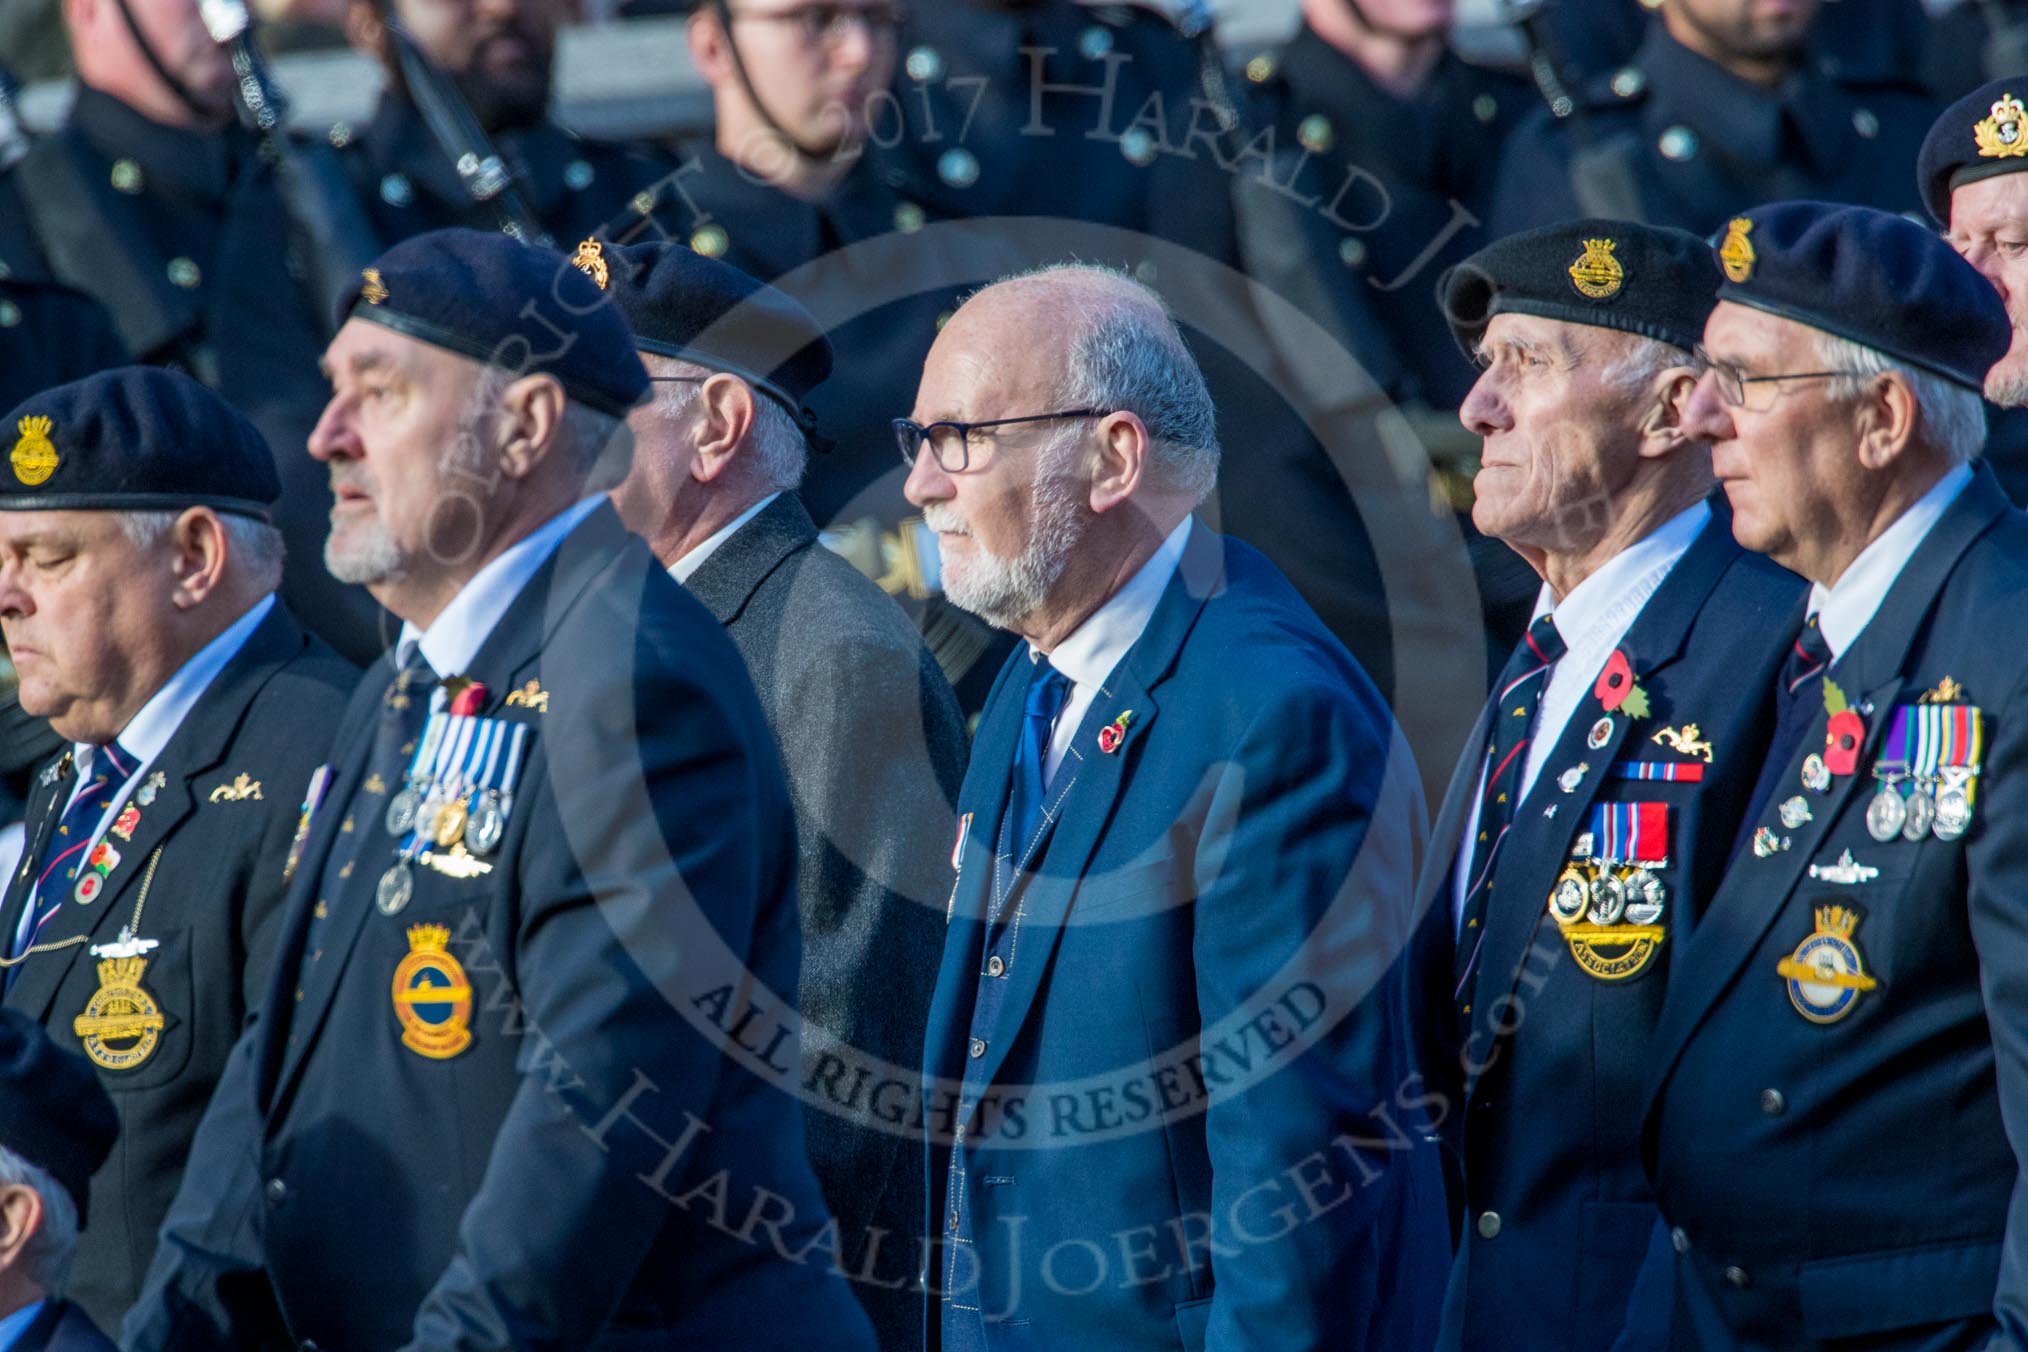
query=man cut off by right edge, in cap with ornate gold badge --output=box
[1916,75,2028,503]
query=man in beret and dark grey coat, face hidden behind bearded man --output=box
[586,243,965,1348]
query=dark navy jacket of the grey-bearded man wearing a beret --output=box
[124,505,870,1352]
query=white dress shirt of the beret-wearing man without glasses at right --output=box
[1450,503,1712,928]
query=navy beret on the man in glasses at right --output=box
[1716,203,2014,389]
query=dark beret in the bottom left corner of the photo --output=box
[0,1009,120,1222]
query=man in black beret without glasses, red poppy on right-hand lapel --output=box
[1411,219,1801,1352]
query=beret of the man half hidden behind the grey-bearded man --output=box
[576,239,831,430]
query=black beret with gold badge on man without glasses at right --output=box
[1444,219,1718,357]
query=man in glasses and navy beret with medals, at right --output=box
[1639,203,2028,1352]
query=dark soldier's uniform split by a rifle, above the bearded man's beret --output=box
[331,91,669,251]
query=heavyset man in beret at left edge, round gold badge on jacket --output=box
[0,367,357,1328]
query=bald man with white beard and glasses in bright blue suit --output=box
[896,268,1442,1352]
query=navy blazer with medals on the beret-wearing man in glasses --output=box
[1641,466,2028,1352]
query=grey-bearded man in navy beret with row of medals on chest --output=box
[124,231,870,1352]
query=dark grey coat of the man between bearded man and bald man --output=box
[687,493,967,1348]
